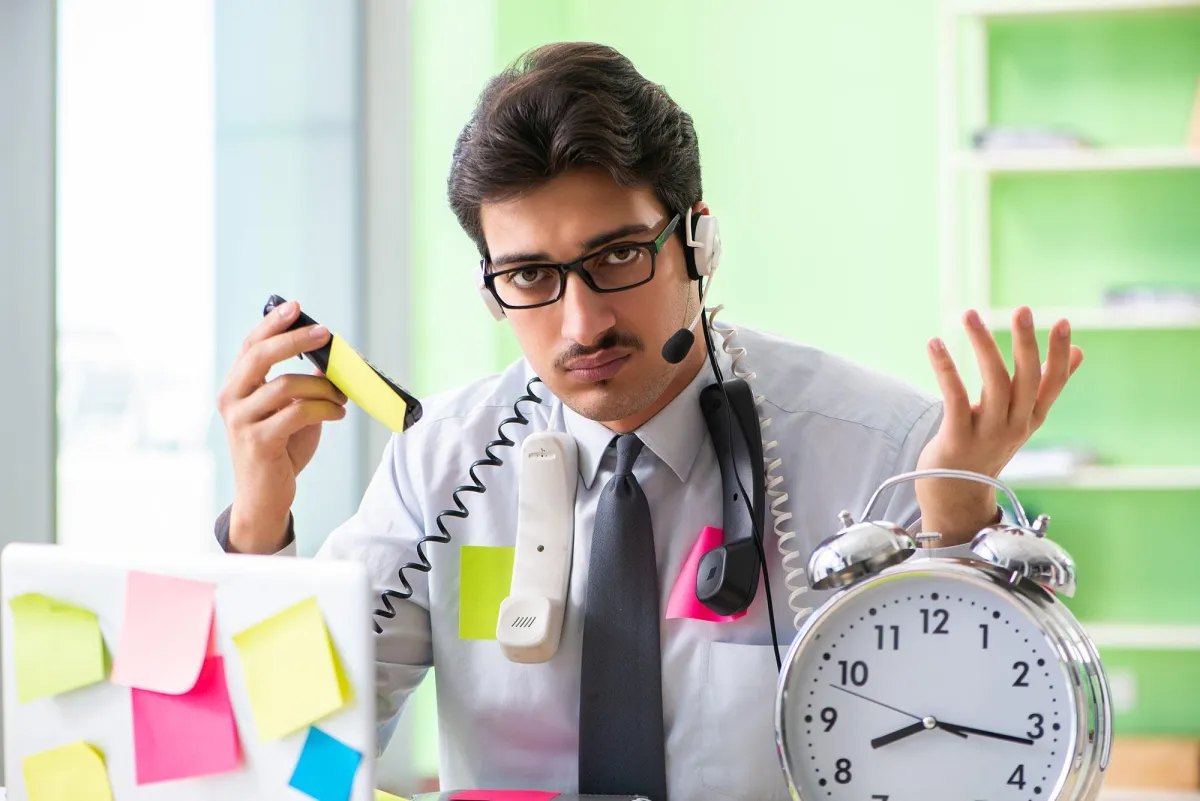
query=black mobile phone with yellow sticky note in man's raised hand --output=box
[263,295,421,433]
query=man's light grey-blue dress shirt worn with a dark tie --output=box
[319,329,960,801]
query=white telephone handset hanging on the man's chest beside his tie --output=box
[496,432,580,663]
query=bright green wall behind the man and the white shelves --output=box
[412,0,1200,766]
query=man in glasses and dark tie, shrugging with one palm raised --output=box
[218,44,1082,801]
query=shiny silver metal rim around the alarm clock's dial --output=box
[774,556,1112,801]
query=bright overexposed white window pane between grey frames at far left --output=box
[56,0,215,549]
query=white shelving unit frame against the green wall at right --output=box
[938,0,1200,714]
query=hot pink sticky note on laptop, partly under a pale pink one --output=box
[131,656,239,784]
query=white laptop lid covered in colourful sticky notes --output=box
[0,543,377,801]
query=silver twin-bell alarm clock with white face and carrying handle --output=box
[775,470,1112,801]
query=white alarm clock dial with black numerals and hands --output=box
[784,573,1075,801]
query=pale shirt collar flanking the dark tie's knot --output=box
[563,343,731,489]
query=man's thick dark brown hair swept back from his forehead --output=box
[448,42,702,258]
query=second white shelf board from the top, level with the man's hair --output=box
[956,146,1200,175]
